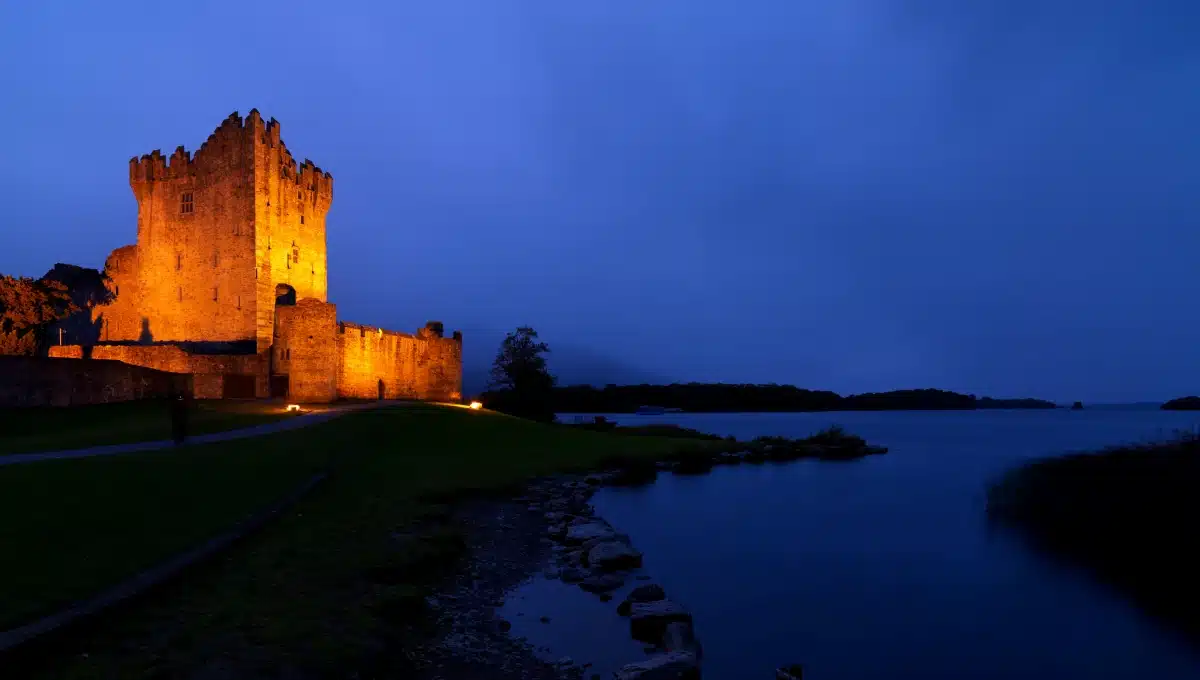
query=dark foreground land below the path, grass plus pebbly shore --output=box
[0,405,721,680]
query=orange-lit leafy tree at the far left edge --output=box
[0,275,79,355]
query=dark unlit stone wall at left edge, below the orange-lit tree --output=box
[0,356,191,408]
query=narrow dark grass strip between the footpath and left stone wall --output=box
[0,399,293,455]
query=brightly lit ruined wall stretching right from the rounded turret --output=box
[337,323,462,401]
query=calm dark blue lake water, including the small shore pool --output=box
[502,410,1200,680]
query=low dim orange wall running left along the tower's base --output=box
[50,344,270,399]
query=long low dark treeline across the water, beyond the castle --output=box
[480,383,1057,414]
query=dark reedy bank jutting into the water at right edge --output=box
[989,438,1200,643]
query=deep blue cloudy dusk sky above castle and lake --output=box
[0,0,1200,401]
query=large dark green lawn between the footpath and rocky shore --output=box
[0,407,708,678]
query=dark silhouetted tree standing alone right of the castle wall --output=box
[490,326,554,421]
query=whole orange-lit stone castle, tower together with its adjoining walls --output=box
[50,110,462,402]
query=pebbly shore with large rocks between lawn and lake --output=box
[413,471,702,680]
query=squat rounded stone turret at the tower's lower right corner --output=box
[271,299,337,403]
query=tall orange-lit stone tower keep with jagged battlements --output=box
[95,110,334,353]
